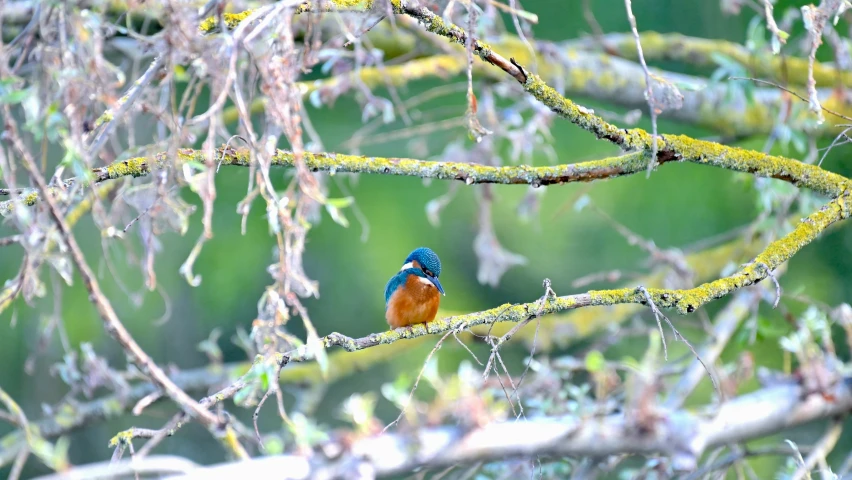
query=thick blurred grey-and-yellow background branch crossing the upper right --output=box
[216,18,852,137]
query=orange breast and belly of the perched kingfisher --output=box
[385,275,441,328]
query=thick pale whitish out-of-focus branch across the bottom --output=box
[36,378,852,480]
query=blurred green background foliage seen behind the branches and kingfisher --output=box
[0,0,852,474]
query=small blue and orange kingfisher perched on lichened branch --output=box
[385,247,446,328]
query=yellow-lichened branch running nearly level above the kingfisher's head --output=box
[0,135,852,216]
